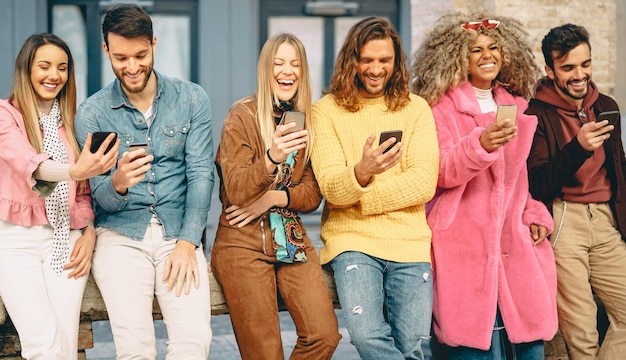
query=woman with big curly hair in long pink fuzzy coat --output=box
[412,12,558,360]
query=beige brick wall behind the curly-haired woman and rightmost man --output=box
[411,0,620,96]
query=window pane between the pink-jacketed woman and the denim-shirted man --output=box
[52,5,87,104]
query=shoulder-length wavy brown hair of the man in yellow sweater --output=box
[324,17,409,112]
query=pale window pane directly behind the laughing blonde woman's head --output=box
[268,16,324,101]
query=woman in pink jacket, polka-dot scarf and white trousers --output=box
[0,34,118,360]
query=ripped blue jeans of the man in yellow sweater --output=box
[331,251,433,360]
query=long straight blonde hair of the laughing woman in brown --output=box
[254,33,313,162]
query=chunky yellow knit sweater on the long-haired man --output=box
[311,94,439,264]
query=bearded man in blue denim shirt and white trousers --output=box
[75,5,213,360]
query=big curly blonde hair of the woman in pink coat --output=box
[411,10,541,105]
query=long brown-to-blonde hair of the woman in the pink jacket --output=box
[9,33,80,158]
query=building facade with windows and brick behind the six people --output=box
[0,0,626,135]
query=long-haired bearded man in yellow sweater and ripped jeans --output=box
[311,17,439,360]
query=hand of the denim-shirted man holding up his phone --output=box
[111,149,154,194]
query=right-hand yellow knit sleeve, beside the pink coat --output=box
[361,98,439,215]
